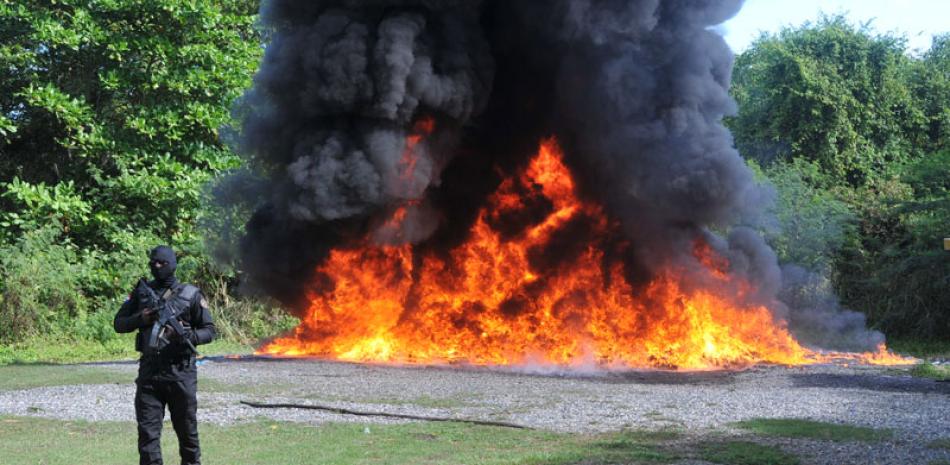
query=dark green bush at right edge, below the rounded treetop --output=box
[836,151,950,339]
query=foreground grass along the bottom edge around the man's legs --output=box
[0,417,675,465]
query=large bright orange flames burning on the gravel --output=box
[259,136,907,369]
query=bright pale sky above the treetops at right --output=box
[717,0,950,53]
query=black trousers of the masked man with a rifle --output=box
[135,371,201,465]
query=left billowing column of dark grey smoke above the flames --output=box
[237,0,493,302]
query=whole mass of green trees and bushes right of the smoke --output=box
[727,16,950,339]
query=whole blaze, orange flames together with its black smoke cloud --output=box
[229,0,916,368]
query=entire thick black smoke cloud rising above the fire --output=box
[229,0,877,348]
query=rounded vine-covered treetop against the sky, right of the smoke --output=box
[727,16,931,186]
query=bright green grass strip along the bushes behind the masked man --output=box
[0,333,254,365]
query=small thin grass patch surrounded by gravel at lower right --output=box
[734,418,893,442]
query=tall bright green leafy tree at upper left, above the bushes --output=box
[0,0,262,252]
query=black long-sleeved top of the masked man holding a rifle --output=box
[113,281,217,379]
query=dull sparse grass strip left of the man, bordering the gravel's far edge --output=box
[0,365,135,391]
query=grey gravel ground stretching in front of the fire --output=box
[0,357,950,464]
